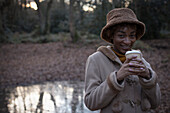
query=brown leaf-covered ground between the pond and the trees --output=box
[0,39,170,113]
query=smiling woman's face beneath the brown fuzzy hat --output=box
[113,25,136,54]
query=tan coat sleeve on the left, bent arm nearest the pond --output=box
[84,56,124,111]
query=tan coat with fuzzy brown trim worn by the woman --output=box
[84,46,161,113]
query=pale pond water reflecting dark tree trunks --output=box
[0,81,99,113]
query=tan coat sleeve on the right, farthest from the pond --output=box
[139,59,161,109]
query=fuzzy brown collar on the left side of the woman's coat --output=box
[97,46,122,65]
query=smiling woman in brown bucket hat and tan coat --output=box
[84,8,160,113]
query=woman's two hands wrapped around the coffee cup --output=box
[117,56,150,81]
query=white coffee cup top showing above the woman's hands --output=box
[125,50,142,59]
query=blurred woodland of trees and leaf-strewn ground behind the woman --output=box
[0,0,170,113]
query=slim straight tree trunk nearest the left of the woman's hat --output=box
[69,0,78,42]
